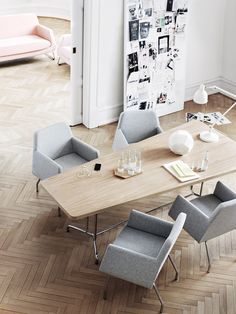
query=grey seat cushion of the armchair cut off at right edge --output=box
[191,194,222,217]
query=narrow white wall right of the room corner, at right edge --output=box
[222,0,236,93]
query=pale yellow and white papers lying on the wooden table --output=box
[163,160,199,182]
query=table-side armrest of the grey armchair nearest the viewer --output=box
[127,210,173,237]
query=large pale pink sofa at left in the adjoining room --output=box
[0,14,56,61]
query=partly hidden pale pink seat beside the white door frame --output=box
[57,34,71,65]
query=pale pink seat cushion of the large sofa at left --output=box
[0,35,51,57]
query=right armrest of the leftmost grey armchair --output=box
[72,137,100,161]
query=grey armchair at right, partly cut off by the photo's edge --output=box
[169,181,236,272]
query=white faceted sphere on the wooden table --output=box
[169,130,194,155]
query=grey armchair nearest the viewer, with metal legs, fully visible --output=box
[100,210,186,313]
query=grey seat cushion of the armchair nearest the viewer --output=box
[114,227,166,257]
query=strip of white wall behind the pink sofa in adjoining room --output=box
[0,0,71,19]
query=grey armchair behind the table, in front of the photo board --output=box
[112,110,162,150]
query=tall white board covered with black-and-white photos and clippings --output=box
[124,0,188,116]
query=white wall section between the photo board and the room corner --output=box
[186,0,226,99]
